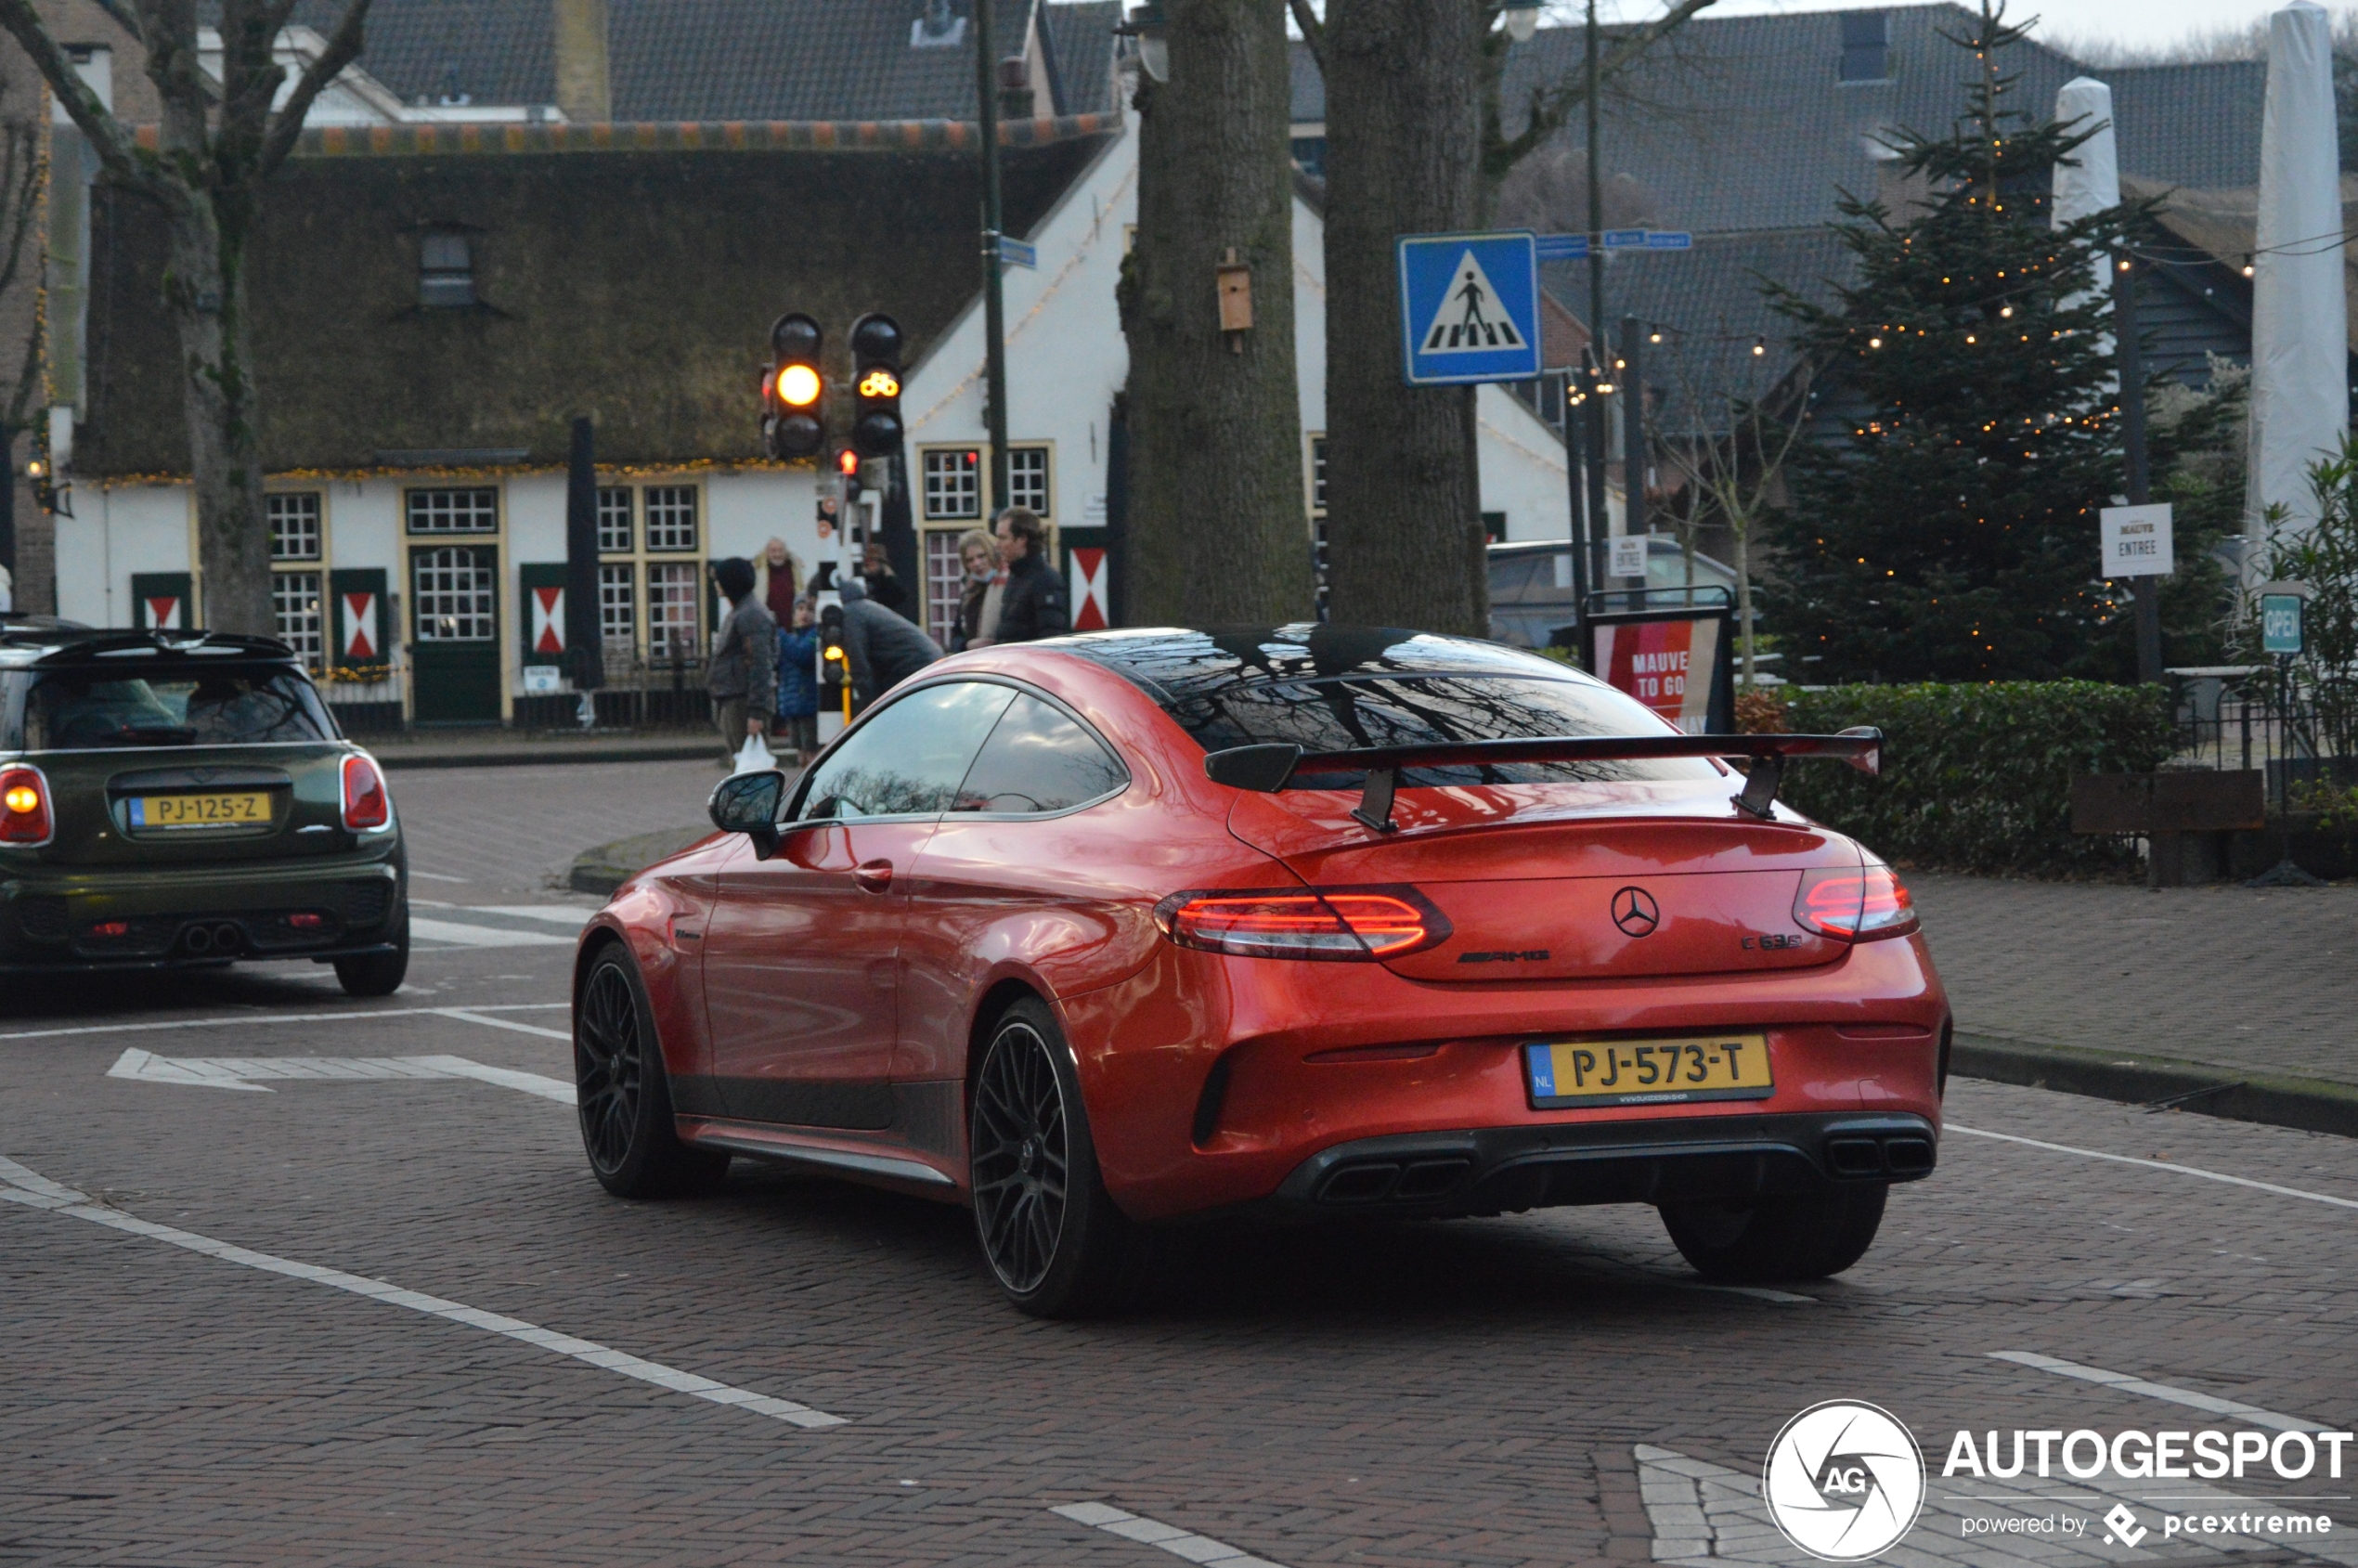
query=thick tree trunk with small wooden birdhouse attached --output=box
[1122,0,1311,625]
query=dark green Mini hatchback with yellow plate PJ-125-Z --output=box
[0,617,410,997]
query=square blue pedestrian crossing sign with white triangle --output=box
[1398,231,1540,387]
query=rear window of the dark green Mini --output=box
[0,663,337,752]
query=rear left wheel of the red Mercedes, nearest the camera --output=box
[966,997,1151,1318]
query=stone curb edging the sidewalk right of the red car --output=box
[1950,1032,2358,1139]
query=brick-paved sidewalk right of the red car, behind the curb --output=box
[1908,873,2358,1082]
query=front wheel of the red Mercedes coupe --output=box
[573,943,729,1198]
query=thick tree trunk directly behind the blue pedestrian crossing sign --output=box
[1323,0,1490,637]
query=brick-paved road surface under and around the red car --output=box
[0,769,2358,1568]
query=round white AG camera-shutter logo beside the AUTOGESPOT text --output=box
[1761,1398,1924,1563]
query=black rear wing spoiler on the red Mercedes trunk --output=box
[1202,729,1884,833]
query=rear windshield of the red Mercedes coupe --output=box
[1167,674,1719,790]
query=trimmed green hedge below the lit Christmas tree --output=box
[1781,681,2174,873]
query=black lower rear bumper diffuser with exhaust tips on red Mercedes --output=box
[1266,1113,1940,1219]
